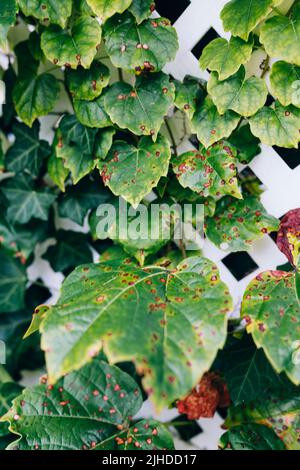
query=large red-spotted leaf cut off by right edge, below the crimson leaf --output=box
[241,271,300,384]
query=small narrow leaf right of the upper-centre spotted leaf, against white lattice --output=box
[174,75,204,119]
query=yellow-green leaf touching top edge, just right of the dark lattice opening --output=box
[221,0,281,41]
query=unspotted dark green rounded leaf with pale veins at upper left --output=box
[13,73,60,127]
